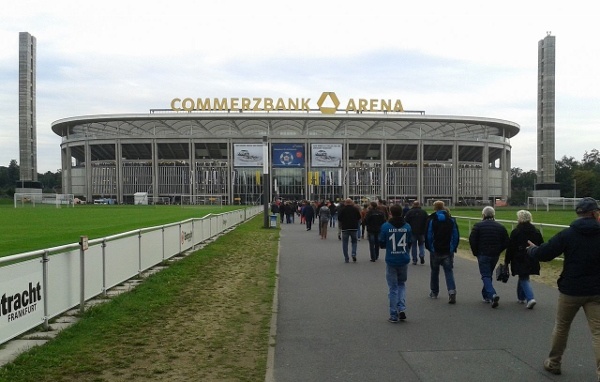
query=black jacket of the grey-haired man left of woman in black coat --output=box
[469,219,508,257]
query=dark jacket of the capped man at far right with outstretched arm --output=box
[528,218,600,296]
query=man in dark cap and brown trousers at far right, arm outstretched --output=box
[527,197,600,381]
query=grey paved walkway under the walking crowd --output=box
[267,223,596,382]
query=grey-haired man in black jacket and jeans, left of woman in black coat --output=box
[469,206,509,308]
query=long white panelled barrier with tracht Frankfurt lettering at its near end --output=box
[0,206,263,345]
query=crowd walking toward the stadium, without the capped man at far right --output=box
[271,198,543,314]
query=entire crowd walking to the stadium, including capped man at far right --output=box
[271,198,600,382]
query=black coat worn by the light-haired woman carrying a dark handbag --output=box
[504,222,544,276]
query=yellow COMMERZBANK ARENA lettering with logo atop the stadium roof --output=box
[171,92,404,114]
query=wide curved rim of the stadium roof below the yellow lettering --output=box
[52,111,520,140]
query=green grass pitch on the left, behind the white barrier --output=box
[0,204,244,257]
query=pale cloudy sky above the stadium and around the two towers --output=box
[0,0,600,172]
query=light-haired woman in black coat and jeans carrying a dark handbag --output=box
[505,210,544,309]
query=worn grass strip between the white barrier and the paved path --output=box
[0,216,279,382]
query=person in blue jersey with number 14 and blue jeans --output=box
[379,205,412,323]
